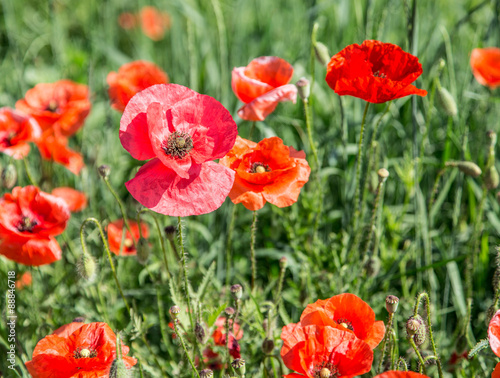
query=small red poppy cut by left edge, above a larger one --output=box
[0,108,41,159]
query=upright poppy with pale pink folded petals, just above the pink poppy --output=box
[231,56,297,121]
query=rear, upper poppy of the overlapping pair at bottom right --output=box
[300,293,385,349]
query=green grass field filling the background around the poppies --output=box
[0,0,500,377]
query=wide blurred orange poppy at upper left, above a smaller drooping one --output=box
[16,80,91,137]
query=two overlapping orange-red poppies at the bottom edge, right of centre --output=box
[281,294,385,378]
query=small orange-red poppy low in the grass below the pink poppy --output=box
[108,219,149,255]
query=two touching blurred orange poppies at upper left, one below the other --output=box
[16,80,91,174]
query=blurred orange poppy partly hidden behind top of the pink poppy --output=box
[106,60,168,112]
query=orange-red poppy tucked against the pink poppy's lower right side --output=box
[220,137,311,210]
